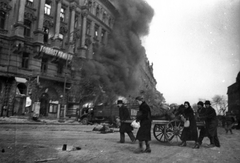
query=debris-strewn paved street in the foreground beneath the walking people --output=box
[0,124,240,163]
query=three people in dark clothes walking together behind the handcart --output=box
[180,101,220,148]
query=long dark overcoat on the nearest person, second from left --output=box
[136,102,152,141]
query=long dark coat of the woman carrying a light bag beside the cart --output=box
[181,107,198,141]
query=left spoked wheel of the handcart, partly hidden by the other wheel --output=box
[153,124,168,142]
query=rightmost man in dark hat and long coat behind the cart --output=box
[203,100,220,148]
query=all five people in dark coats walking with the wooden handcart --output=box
[117,96,220,153]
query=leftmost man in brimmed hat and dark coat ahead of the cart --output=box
[117,100,136,143]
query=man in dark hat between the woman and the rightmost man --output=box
[197,101,211,148]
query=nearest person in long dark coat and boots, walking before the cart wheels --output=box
[135,96,152,153]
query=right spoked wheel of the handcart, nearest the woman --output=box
[164,120,183,142]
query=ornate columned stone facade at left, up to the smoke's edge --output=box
[0,0,117,117]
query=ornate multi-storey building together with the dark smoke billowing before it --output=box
[0,0,162,117]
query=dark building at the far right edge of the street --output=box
[227,72,240,119]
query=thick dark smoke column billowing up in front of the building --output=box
[80,0,154,100]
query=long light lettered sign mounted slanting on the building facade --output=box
[39,45,73,60]
